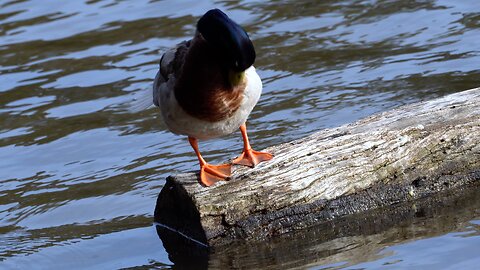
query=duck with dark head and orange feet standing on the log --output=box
[133,9,273,187]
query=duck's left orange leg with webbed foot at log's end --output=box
[188,137,232,187]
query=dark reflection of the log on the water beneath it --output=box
[157,184,480,269]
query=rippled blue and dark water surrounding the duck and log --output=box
[0,0,480,269]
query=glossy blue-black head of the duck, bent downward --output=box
[197,9,256,72]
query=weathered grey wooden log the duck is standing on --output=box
[155,88,480,246]
